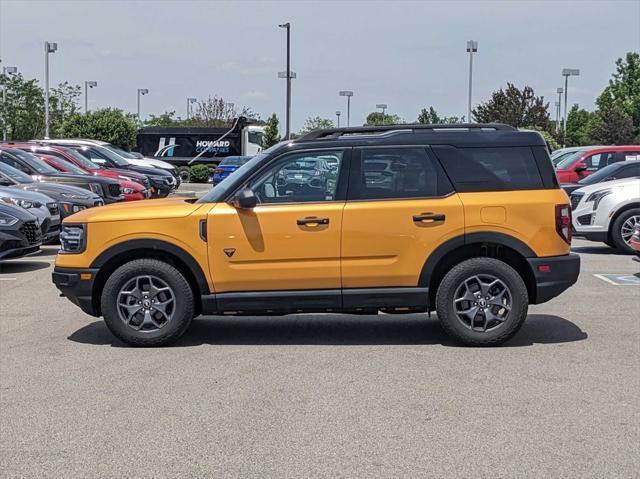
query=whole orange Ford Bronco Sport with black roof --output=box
[53,124,580,346]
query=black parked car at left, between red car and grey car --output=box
[0,147,124,203]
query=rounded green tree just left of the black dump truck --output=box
[57,108,137,150]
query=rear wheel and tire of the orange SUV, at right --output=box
[436,258,529,346]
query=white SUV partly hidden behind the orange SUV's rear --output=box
[571,178,640,253]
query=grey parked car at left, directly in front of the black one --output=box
[0,162,104,218]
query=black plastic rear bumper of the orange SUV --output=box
[527,253,580,304]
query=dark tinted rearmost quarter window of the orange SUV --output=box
[433,146,545,192]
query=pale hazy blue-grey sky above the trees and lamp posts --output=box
[0,0,640,131]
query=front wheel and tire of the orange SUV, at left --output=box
[100,259,194,346]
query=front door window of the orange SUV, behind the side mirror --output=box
[247,151,343,204]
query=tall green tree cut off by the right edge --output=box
[596,52,640,134]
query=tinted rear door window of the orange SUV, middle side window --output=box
[348,147,452,200]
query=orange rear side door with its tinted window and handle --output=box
[342,146,464,292]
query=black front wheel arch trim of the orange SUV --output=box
[91,239,210,315]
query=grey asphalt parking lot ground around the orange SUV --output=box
[0,240,640,478]
